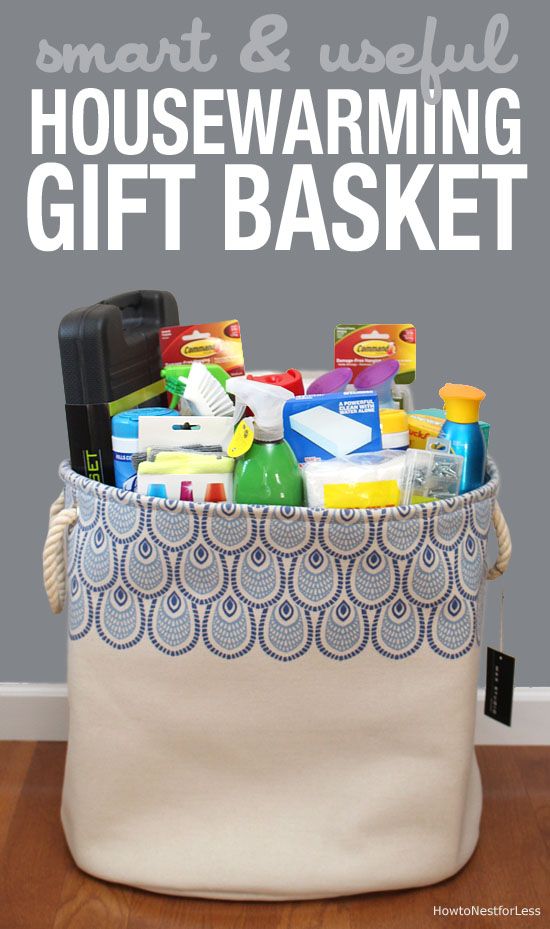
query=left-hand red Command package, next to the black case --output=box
[160,319,245,377]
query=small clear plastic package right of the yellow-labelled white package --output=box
[401,438,464,504]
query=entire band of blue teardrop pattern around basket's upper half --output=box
[61,454,500,662]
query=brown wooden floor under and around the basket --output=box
[0,742,550,929]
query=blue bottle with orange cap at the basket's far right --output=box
[439,384,487,494]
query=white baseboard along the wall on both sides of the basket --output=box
[0,684,550,745]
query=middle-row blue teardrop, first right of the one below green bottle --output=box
[288,548,343,608]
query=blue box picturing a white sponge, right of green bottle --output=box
[283,391,382,462]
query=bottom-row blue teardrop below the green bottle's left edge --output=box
[203,594,256,658]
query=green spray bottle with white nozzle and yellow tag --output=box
[226,377,304,506]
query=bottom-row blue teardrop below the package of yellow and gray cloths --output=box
[147,588,200,655]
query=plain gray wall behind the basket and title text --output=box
[0,0,550,685]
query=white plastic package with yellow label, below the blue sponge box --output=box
[302,451,405,509]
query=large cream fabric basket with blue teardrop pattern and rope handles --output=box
[45,464,509,899]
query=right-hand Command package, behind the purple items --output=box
[334,323,416,384]
